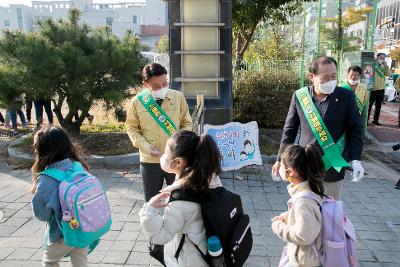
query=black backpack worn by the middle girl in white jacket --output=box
[169,187,253,267]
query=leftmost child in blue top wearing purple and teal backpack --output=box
[31,127,111,267]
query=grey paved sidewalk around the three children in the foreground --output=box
[0,163,400,267]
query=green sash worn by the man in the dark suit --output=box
[296,87,350,172]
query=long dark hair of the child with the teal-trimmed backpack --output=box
[31,127,89,193]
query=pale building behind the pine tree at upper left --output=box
[0,0,168,38]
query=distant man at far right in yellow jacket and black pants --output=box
[368,53,390,125]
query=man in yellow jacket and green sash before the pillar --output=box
[125,63,193,202]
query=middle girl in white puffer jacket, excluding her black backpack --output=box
[139,131,222,267]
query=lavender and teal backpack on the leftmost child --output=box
[40,162,112,251]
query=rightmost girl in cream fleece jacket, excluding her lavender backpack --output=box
[271,144,325,267]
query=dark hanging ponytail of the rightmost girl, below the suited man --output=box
[304,144,325,196]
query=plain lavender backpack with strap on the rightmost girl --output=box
[289,191,357,267]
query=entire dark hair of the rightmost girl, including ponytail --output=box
[281,144,325,196]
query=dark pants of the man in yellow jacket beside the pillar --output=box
[140,162,175,202]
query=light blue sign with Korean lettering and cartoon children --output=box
[204,121,262,171]
